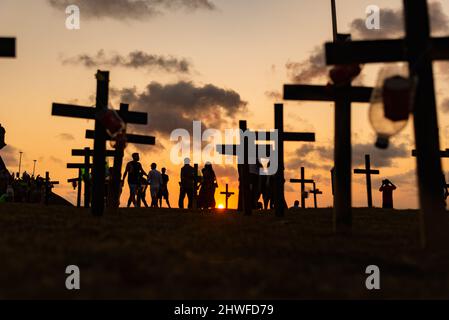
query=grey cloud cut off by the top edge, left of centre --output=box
[48,0,216,21]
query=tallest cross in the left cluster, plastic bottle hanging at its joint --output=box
[52,70,148,216]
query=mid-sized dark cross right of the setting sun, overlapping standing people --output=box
[216,120,274,215]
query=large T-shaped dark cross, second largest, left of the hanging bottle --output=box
[284,85,373,232]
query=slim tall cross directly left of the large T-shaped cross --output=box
[274,103,315,217]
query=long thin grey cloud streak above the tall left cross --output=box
[62,50,192,74]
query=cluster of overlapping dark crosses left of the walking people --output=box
[52,70,156,216]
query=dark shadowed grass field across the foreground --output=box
[0,204,449,299]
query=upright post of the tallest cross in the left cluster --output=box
[92,70,109,216]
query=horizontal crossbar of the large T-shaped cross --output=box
[284,84,373,102]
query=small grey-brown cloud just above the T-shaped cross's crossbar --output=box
[285,46,327,83]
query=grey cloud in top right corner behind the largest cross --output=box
[350,2,449,39]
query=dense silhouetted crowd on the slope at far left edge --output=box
[0,169,53,203]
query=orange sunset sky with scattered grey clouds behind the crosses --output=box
[0,0,449,208]
